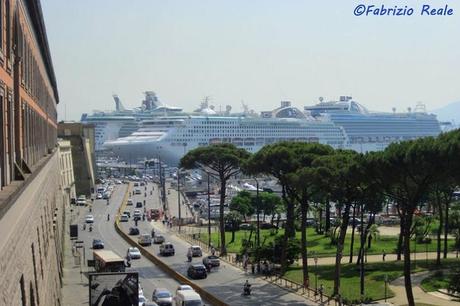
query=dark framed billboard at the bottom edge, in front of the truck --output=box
[88,272,139,306]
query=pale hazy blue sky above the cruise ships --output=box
[42,0,460,120]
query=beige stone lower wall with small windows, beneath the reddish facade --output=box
[0,152,68,306]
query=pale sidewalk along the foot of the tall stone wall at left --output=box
[62,202,89,306]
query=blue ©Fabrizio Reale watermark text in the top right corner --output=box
[353,4,454,16]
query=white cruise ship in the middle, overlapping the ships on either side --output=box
[104,102,346,165]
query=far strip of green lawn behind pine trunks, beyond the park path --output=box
[200,228,454,257]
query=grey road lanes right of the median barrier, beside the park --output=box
[120,184,316,306]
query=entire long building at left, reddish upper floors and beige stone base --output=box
[0,0,63,306]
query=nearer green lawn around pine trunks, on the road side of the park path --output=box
[286,259,460,301]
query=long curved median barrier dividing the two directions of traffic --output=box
[114,183,229,306]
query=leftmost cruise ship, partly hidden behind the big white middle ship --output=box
[80,91,182,151]
